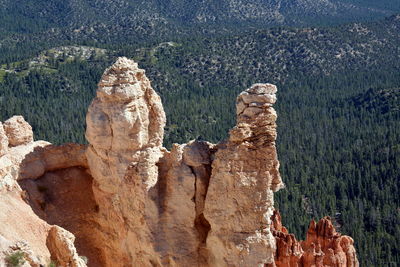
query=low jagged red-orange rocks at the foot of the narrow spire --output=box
[270,211,359,267]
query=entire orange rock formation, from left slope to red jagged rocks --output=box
[0,58,358,267]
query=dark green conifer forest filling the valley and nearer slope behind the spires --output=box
[0,5,400,266]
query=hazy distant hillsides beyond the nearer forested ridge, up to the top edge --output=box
[0,0,400,61]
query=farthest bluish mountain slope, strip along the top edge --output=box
[0,0,400,33]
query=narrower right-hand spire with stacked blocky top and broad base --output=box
[204,84,283,266]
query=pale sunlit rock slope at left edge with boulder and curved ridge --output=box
[0,116,86,267]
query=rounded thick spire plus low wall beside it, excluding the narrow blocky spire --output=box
[86,58,216,266]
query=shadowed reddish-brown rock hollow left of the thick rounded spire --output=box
[19,166,104,266]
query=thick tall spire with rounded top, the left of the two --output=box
[86,58,166,266]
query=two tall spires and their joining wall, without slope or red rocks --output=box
[86,58,282,266]
